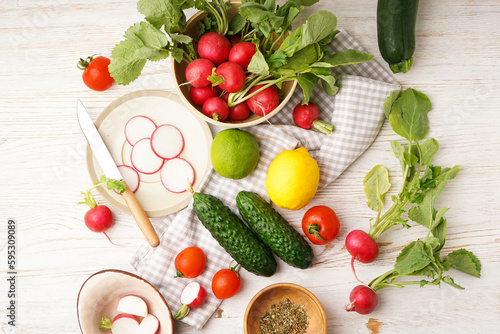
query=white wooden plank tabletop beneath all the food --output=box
[0,0,500,334]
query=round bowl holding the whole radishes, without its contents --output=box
[172,2,297,128]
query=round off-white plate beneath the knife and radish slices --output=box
[87,90,212,218]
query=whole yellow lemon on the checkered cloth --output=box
[266,147,319,210]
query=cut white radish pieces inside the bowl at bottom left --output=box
[99,295,160,334]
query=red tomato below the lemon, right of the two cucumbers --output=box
[302,205,340,245]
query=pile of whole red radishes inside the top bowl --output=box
[185,32,280,122]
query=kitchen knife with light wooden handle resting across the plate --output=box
[76,100,160,247]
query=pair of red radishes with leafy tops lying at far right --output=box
[346,88,481,314]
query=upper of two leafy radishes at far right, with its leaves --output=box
[346,88,460,263]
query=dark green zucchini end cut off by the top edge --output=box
[377,0,418,73]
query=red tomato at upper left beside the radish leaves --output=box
[78,56,115,91]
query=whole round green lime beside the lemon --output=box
[210,129,259,180]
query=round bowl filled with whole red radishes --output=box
[172,2,297,128]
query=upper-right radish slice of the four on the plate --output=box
[151,124,184,159]
